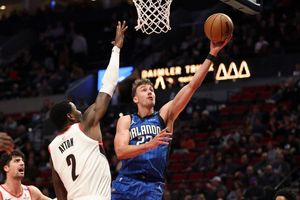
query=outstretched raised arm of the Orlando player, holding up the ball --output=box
[160,38,231,124]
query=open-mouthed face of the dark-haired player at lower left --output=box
[4,156,25,179]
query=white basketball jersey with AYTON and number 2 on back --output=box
[49,123,111,200]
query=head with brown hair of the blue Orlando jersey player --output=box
[131,79,155,107]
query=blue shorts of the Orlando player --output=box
[111,176,165,200]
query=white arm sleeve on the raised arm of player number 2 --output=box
[100,46,120,97]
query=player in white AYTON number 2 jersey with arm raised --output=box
[49,21,127,200]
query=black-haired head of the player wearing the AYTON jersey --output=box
[50,101,82,131]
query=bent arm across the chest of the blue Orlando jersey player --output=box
[114,115,172,160]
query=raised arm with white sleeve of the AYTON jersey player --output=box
[83,21,127,131]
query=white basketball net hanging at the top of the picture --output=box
[133,0,172,34]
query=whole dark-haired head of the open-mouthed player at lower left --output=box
[0,150,25,180]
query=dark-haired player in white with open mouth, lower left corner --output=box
[0,150,50,200]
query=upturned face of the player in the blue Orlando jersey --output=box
[133,84,155,107]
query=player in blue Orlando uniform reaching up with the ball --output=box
[112,38,230,200]
